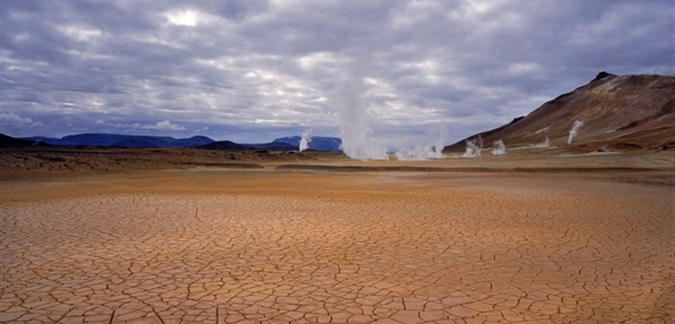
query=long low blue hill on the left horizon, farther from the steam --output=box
[23,134,214,148]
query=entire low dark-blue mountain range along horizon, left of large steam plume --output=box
[10,133,342,152]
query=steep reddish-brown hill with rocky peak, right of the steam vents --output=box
[445,72,675,151]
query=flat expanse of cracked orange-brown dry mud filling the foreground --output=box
[0,170,675,323]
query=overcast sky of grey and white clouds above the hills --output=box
[0,0,675,143]
